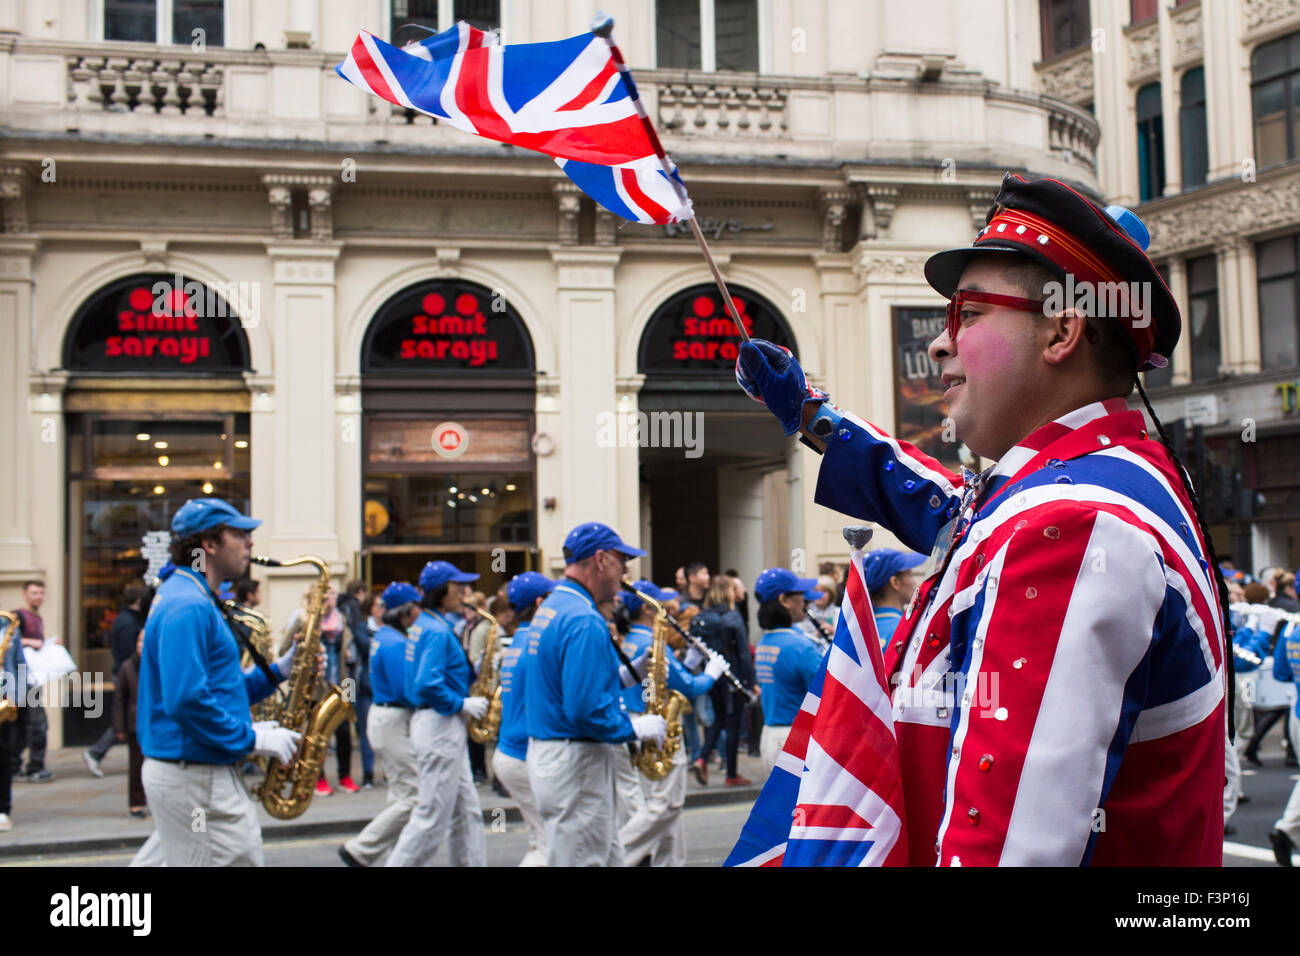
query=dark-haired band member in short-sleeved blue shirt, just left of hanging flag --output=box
[754,567,826,774]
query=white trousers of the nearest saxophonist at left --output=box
[131,757,265,866]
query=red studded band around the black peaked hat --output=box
[974,206,1156,359]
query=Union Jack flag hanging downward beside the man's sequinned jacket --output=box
[725,550,907,866]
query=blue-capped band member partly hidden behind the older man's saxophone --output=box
[619,579,727,866]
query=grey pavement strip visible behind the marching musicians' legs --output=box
[0,745,764,858]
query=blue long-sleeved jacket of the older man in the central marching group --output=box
[524,579,636,744]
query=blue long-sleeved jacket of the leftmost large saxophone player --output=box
[135,567,276,763]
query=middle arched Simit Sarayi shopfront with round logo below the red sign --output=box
[360,280,537,596]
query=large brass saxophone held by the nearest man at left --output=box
[254,554,356,819]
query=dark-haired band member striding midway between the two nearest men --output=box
[387,561,488,866]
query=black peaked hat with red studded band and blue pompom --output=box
[926,173,1183,371]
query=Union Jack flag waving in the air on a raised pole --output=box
[334,22,692,224]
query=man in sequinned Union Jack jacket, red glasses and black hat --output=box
[737,174,1230,866]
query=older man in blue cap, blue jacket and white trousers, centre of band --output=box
[524,522,667,866]
